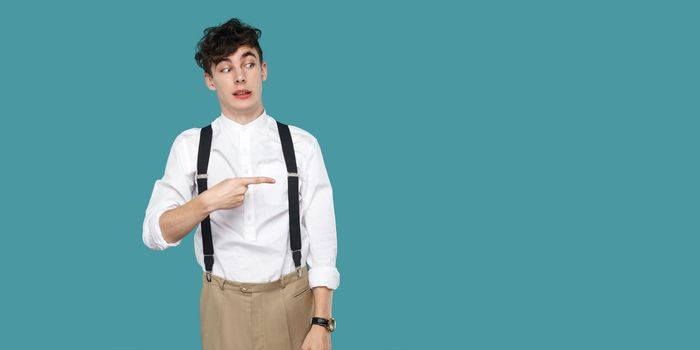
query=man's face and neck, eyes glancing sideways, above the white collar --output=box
[204,46,267,117]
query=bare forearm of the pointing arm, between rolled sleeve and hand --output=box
[159,192,213,243]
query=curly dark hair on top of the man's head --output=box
[194,18,263,75]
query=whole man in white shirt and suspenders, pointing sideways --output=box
[143,18,340,350]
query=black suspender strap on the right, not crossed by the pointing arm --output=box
[277,121,301,273]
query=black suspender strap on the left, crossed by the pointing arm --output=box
[197,124,214,282]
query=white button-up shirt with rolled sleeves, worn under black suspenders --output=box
[143,110,340,289]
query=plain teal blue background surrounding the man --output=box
[0,1,700,350]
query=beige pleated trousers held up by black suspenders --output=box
[199,265,314,350]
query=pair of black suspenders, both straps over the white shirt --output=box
[197,121,301,282]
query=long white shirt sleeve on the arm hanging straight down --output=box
[301,138,340,289]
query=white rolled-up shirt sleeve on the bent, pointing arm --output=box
[143,132,194,250]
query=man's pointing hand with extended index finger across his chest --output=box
[202,176,275,211]
